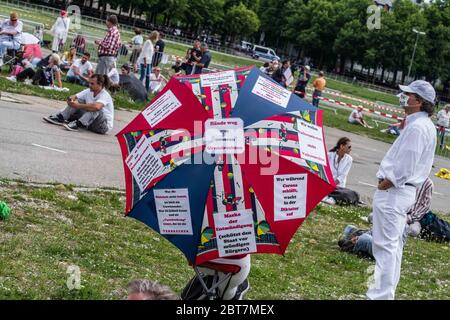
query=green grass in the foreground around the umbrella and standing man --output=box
[0,179,450,299]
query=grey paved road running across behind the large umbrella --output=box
[0,93,450,212]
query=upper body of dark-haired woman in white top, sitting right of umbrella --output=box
[328,137,353,188]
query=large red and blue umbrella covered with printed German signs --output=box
[118,68,334,265]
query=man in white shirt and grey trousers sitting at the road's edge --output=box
[44,74,114,134]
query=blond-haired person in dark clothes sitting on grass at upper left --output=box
[17,53,63,88]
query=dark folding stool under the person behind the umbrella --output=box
[181,261,241,300]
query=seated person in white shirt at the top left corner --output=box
[0,12,23,67]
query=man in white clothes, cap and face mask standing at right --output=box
[366,80,437,300]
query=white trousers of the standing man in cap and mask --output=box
[366,186,416,300]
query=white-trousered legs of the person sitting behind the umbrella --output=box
[198,254,250,300]
